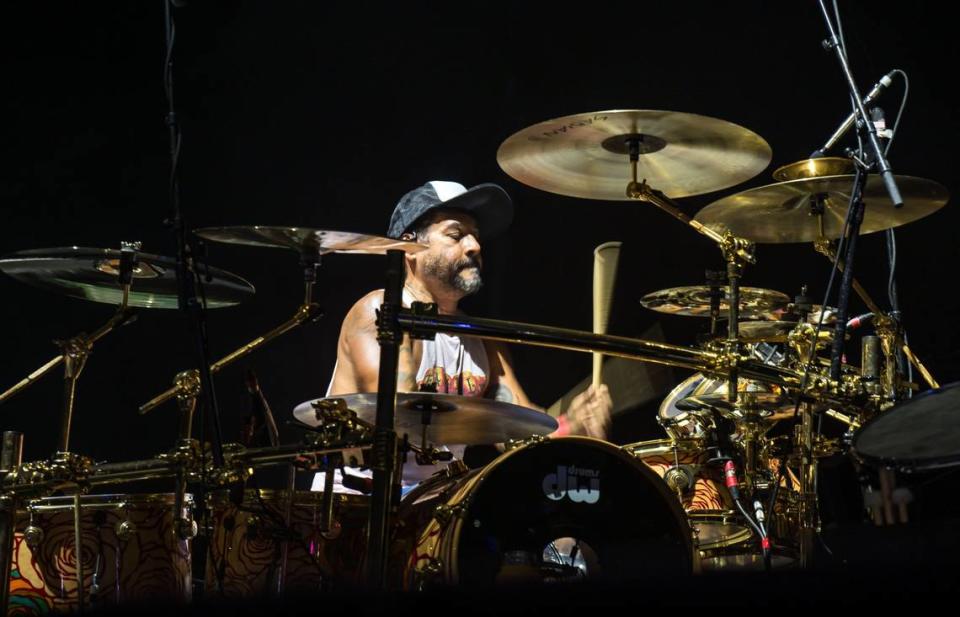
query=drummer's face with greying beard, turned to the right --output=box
[416,210,483,296]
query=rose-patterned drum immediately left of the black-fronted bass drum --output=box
[206,489,369,598]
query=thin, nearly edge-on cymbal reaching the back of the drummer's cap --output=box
[193,225,427,255]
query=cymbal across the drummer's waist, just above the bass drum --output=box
[293,392,558,445]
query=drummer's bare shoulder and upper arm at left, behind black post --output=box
[330,291,422,396]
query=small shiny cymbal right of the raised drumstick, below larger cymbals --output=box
[640,285,790,320]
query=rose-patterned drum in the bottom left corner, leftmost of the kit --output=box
[9,494,192,614]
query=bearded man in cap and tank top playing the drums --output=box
[314,181,612,489]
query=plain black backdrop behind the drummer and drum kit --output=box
[0,0,960,460]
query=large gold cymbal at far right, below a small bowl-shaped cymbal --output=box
[694,175,949,243]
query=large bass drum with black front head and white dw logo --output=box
[390,437,696,589]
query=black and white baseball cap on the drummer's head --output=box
[387,180,513,238]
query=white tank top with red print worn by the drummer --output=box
[311,289,490,493]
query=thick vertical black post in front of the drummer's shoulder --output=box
[366,250,406,590]
